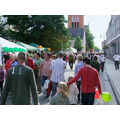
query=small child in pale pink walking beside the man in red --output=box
[68,76,79,105]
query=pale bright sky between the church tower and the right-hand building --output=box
[65,15,111,49]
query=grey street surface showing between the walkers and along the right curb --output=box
[0,61,117,105]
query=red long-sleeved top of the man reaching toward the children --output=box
[67,66,101,94]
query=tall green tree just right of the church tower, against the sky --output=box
[85,28,94,51]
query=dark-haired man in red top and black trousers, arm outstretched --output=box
[67,57,101,105]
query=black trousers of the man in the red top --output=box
[82,93,95,105]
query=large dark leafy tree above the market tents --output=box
[1,15,68,51]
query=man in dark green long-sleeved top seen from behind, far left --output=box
[0,52,38,105]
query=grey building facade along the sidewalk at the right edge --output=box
[104,15,120,59]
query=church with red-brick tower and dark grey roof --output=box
[68,15,86,52]
